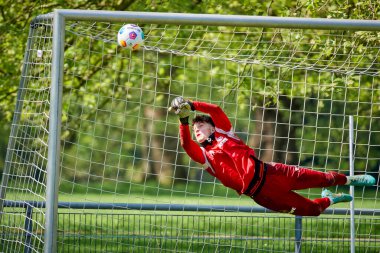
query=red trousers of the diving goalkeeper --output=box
[252,163,347,216]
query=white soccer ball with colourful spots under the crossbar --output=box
[117,24,144,50]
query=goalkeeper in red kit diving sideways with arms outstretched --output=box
[169,97,376,216]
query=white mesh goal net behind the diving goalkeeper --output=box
[0,11,380,252]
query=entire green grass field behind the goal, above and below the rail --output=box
[0,183,380,253]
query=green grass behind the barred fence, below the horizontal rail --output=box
[0,210,380,253]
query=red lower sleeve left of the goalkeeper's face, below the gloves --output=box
[179,124,206,164]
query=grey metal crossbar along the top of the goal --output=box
[40,9,380,31]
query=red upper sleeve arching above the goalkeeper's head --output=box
[192,101,232,132]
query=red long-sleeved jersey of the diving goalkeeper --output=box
[180,101,264,195]
